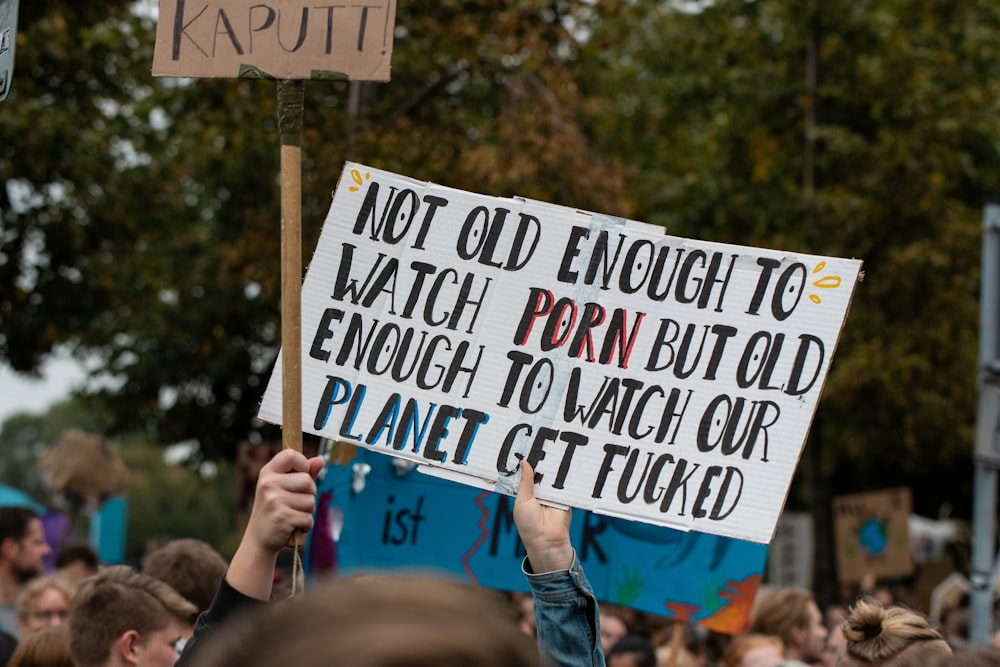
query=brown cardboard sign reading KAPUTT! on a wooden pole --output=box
[153,0,396,81]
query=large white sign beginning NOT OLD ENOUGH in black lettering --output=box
[260,163,861,542]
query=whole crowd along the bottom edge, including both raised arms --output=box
[0,450,1000,667]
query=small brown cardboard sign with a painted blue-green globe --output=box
[833,487,913,583]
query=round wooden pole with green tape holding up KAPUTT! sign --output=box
[278,79,305,553]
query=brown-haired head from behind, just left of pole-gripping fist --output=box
[142,539,229,623]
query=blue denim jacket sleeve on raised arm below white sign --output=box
[521,554,604,667]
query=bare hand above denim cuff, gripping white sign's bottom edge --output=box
[514,461,573,574]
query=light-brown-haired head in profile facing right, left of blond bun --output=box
[750,587,827,662]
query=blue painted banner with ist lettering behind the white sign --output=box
[305,449,768,634]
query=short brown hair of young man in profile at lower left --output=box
[69,565,195,667]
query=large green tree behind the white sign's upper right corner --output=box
[580,2,1000,515]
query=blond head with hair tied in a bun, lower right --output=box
[836,597,952,667]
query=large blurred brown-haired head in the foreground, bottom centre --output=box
[188,576,540,667]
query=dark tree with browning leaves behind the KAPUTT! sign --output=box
[0,1,627,458]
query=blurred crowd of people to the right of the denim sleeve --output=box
[552,587,1000,667]
